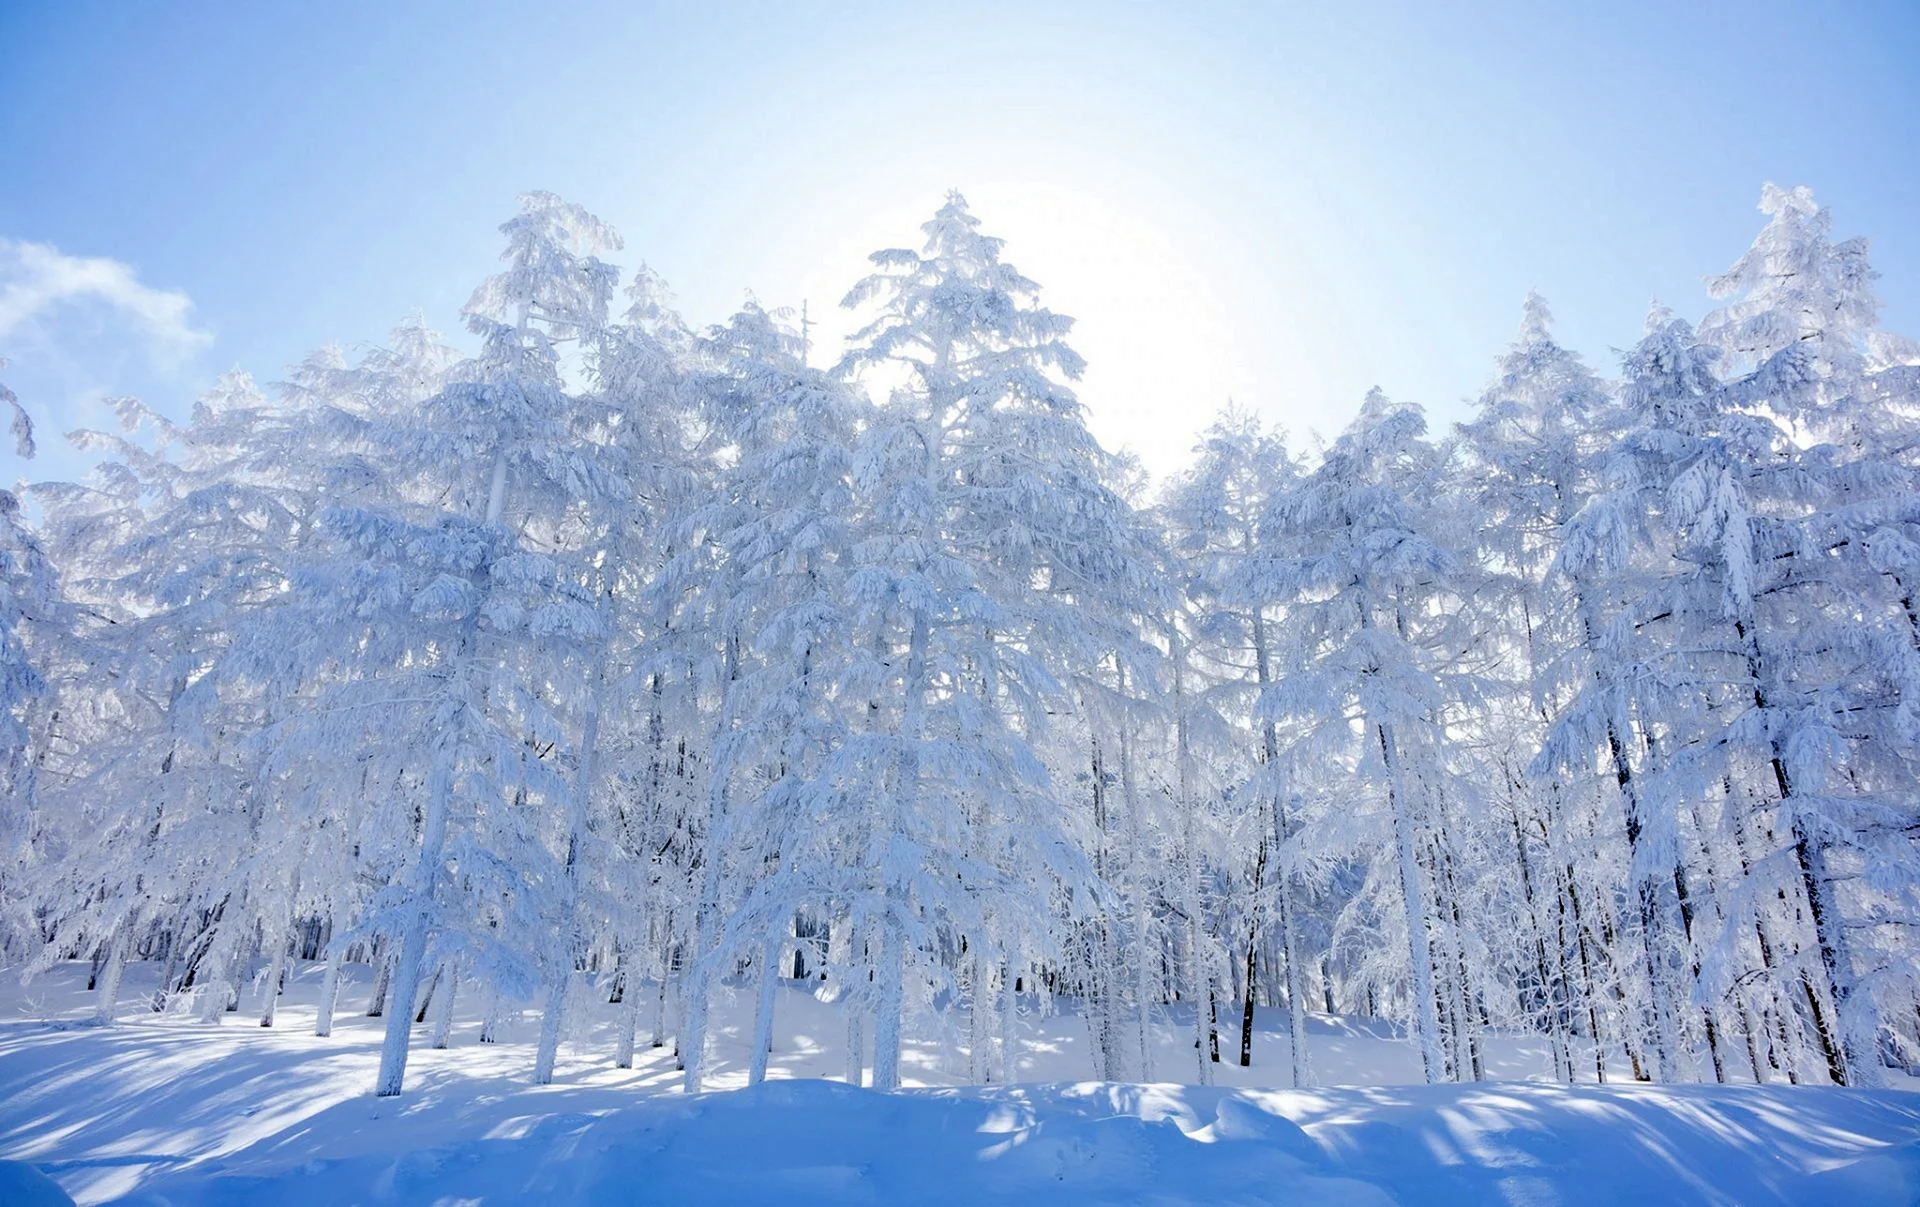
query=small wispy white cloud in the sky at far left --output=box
[0,238,213,365]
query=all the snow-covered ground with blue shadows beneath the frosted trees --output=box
[0,965,1920,1207]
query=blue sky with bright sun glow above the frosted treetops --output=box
[0,0,1920,480]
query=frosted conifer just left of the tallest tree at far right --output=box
[1536,309,1772,1080]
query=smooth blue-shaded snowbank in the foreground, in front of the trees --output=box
[97,1080,1920,1207]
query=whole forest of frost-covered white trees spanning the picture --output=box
[0,186,1920,1096]
